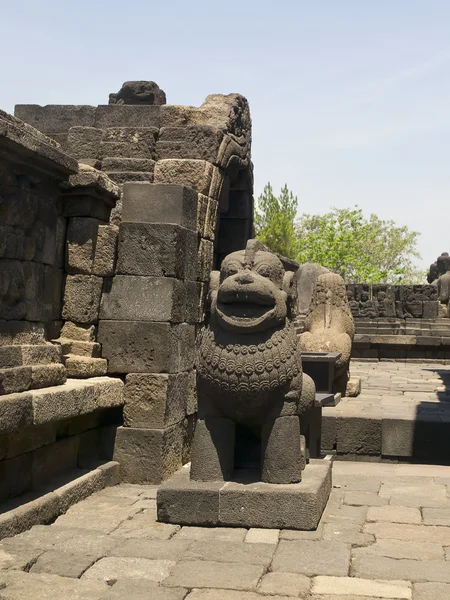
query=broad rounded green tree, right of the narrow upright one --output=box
[296,206,423,283]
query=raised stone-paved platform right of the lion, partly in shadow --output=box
[322,360,450,463]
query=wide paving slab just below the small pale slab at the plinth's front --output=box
[184,540,275,566]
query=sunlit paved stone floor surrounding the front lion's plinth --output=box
[0,462,450,600]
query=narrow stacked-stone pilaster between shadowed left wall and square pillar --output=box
[56,165,120,378]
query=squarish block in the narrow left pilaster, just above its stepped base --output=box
[62,275,103,323]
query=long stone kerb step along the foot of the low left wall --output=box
[0,461,119,539]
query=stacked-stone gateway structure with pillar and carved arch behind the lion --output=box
[16,86,253,482]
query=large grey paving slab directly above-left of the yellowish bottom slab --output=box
[271,540,350,577]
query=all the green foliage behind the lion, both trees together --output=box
[256,184,424,284]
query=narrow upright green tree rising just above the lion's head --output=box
[255,183,298,258]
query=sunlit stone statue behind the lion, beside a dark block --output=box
[300,273,355,395]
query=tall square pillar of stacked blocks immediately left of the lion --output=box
[99,183,203,482]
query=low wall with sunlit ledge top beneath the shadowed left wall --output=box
[0,377,123,502]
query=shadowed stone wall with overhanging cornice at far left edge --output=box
[0,111,78,396]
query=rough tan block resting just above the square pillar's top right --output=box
[155,159,224,200]
